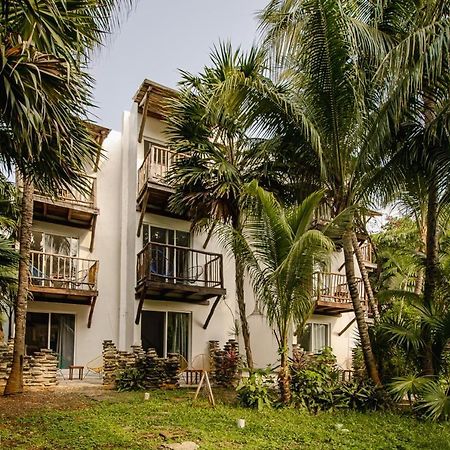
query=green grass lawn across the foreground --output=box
[0,391,450,450]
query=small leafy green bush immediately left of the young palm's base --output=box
[236,368,273,411]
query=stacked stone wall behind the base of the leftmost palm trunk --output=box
[0,341,58,392]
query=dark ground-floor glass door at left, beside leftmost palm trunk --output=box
[25,312,75,369]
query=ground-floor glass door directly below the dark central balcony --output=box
[141,311,191,360]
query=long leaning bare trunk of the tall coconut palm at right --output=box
[342,231,381,385]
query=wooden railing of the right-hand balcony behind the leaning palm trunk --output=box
[314,272,365,304]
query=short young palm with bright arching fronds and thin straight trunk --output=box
[228,181,334,404]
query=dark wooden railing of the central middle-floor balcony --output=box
[136,242,223,288]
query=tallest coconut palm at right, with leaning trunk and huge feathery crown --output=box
[253,0,450,384]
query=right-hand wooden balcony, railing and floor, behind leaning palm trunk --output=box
[314,272,365,315]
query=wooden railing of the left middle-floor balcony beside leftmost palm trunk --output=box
[30,251,98,291]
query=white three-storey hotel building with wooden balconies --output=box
[6,80,373,369]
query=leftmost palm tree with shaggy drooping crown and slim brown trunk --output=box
[0,0,134,394]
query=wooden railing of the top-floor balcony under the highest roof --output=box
[138,144,180,193]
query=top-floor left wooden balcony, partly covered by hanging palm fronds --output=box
[33,177,99,229]
